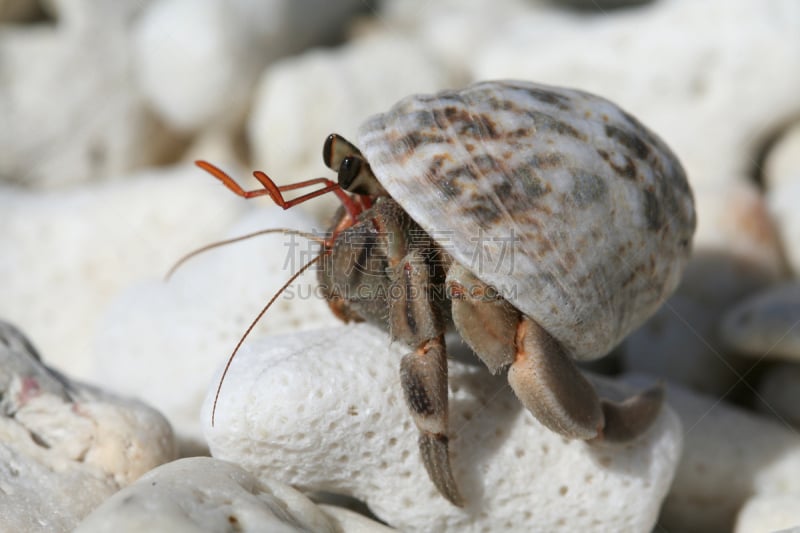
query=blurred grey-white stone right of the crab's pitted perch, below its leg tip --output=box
[623,375,800,532]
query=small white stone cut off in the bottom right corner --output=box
[733,493,800,533]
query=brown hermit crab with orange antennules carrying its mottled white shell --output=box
[192,81,695,505]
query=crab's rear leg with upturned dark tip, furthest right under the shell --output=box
[447,263,663,442]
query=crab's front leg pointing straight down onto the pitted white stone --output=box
[390,251,463,506]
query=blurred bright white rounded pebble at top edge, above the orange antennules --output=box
[134,0,262,131]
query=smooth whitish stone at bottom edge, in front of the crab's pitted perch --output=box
[75,457,390,533]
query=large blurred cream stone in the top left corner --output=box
[0,13,180,188]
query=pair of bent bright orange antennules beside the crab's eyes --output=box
[194,160,363,220]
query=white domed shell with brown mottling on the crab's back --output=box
[358,81,696,359]
